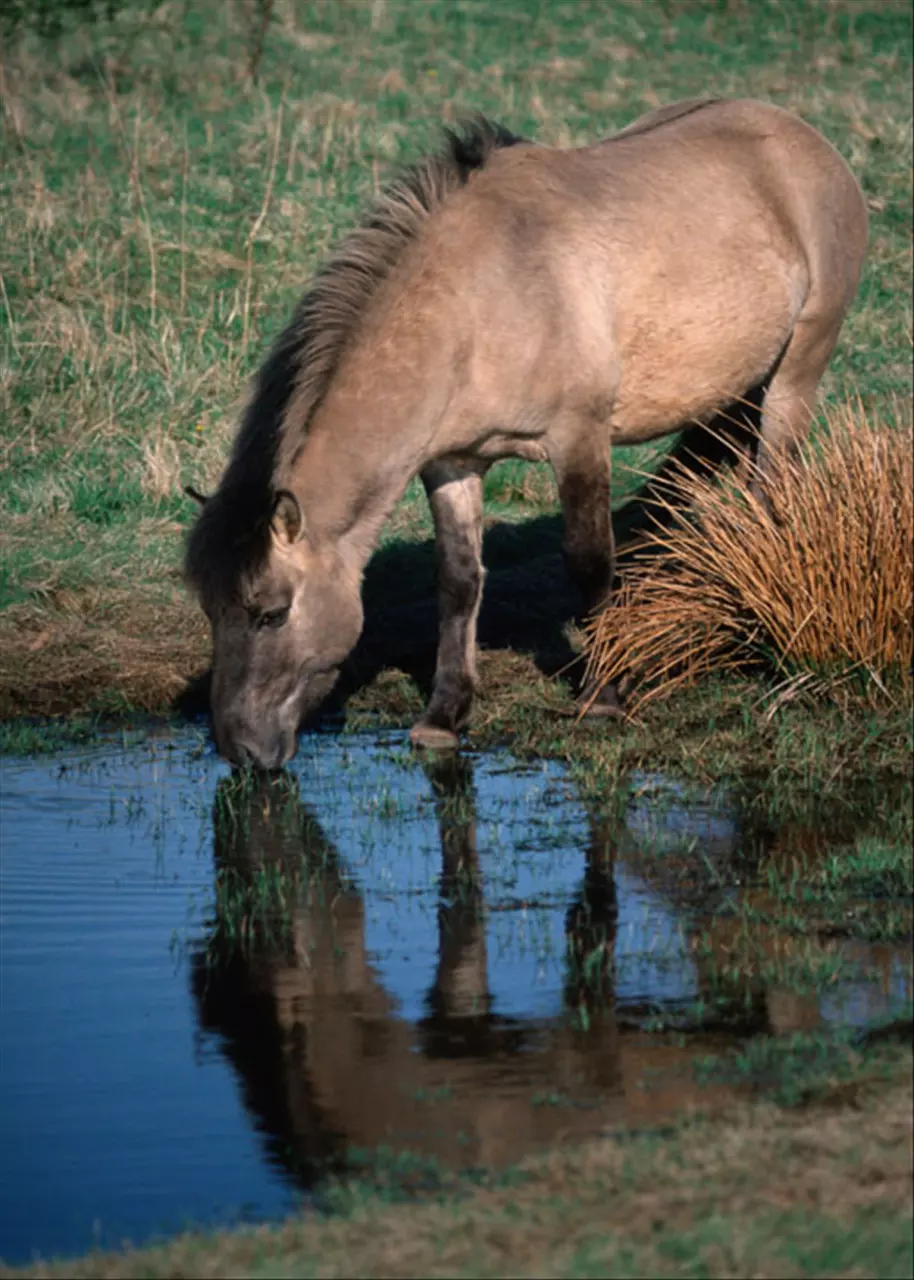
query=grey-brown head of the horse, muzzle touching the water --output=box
[188,490,362,769]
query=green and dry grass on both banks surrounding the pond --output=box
[0,0,914,1276]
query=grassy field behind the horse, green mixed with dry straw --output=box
[0,0,911,745]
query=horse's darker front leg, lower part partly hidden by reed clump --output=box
[549,422,621,716]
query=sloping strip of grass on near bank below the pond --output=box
[5,1053,914,1277]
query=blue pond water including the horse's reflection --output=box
[0,727,910,1262]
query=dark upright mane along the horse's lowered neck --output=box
[184,115,524,598]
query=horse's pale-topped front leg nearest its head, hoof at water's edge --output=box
[410,462,485,748]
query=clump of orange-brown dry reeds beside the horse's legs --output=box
[585,402,914,713]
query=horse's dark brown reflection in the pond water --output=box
[193,755,732,1180]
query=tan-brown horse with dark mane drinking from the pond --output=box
[187,101,867,767]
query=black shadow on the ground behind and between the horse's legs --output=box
[178,401,762,717]
